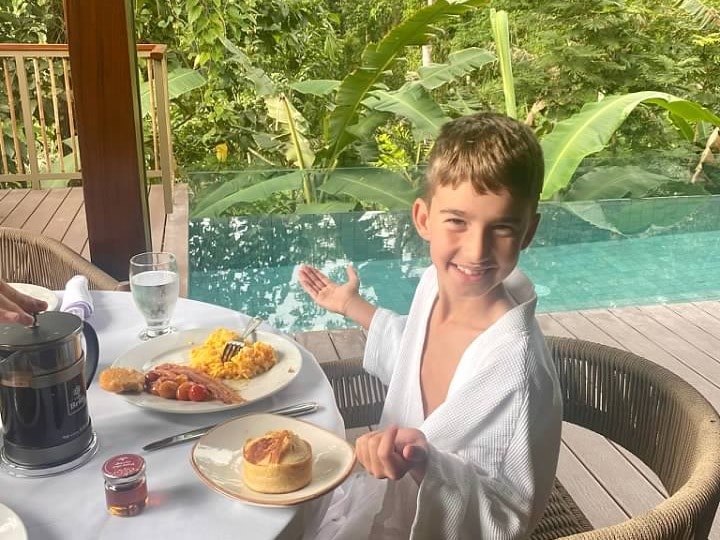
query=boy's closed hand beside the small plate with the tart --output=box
[355,426,428,484]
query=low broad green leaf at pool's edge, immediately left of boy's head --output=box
[320,168,417,210]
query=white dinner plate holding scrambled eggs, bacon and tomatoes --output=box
[112,328,302,414]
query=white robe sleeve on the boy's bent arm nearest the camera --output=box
[412,336,561,540]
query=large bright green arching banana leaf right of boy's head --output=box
[541,91,720,200]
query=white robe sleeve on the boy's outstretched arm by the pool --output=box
[363,308,407,385]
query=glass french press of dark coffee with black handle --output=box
[0,311,98,476]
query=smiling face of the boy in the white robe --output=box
[413,182,539,297]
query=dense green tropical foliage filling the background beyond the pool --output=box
[8,0,720,219]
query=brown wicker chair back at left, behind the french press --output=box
[0,227,119,290]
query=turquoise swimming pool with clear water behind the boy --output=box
[188,197,720,332]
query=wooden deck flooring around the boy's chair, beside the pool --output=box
[295,301,720,539]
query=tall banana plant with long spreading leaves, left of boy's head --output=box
[195,0,492,216]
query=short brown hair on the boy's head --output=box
[424,112,545,210]
